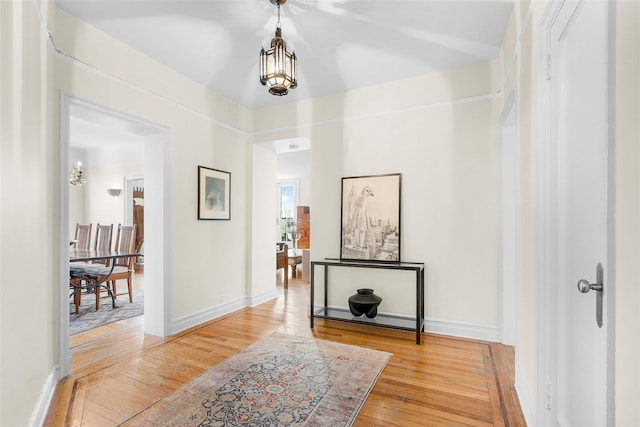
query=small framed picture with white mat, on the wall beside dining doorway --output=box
[198,166,231,220]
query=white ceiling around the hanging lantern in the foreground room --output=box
[57,0,512,109]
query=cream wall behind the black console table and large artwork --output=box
[255,60,502,332]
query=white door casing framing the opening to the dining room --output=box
[59,93,171,377]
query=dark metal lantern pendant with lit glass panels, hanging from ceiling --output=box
[260,0,298,96]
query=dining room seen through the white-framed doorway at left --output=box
[68,106,144,336]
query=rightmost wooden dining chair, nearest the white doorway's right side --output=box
[92,224,136,310]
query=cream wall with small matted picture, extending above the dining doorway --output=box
[53,9,252,327]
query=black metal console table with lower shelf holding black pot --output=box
[310,258,424,344]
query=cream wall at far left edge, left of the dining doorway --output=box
[0,1,57,427]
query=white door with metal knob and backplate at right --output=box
[549,1,613,427]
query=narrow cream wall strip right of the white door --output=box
[615,1,640,426]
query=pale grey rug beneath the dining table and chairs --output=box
[69,285,144,335]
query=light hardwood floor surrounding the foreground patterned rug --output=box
[46,275,525,427]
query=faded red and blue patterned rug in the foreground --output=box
[122,333,391,427]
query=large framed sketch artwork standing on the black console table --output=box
[340,173,402,262]
